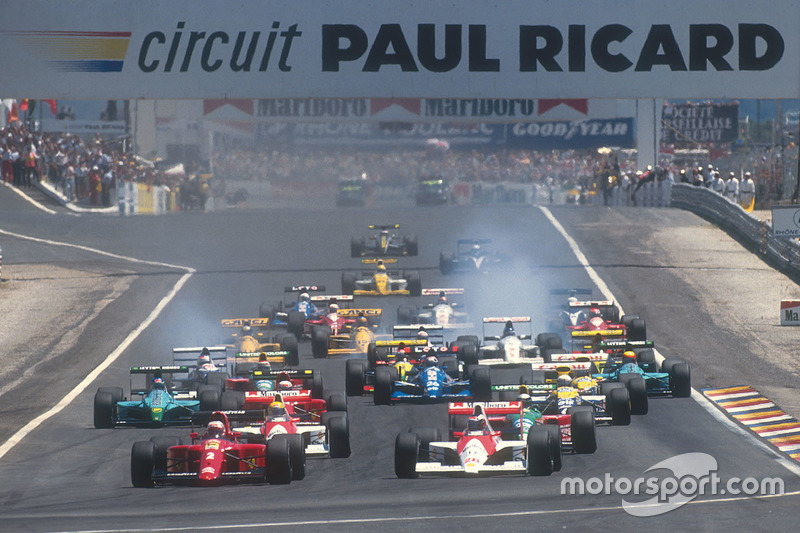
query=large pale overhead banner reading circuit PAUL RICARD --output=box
[0,0,800,99]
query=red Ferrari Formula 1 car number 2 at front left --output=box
[131,412,305,487]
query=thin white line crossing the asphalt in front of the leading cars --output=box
[25,491,800,533]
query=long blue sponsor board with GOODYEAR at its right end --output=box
[256,118,634,150]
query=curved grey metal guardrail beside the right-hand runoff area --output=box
[672,183,800,276]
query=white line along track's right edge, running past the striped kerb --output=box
[537,206,800,476]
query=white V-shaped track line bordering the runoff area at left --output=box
[0,230,195,459]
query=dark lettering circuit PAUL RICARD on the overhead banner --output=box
[138,21,785,72]
